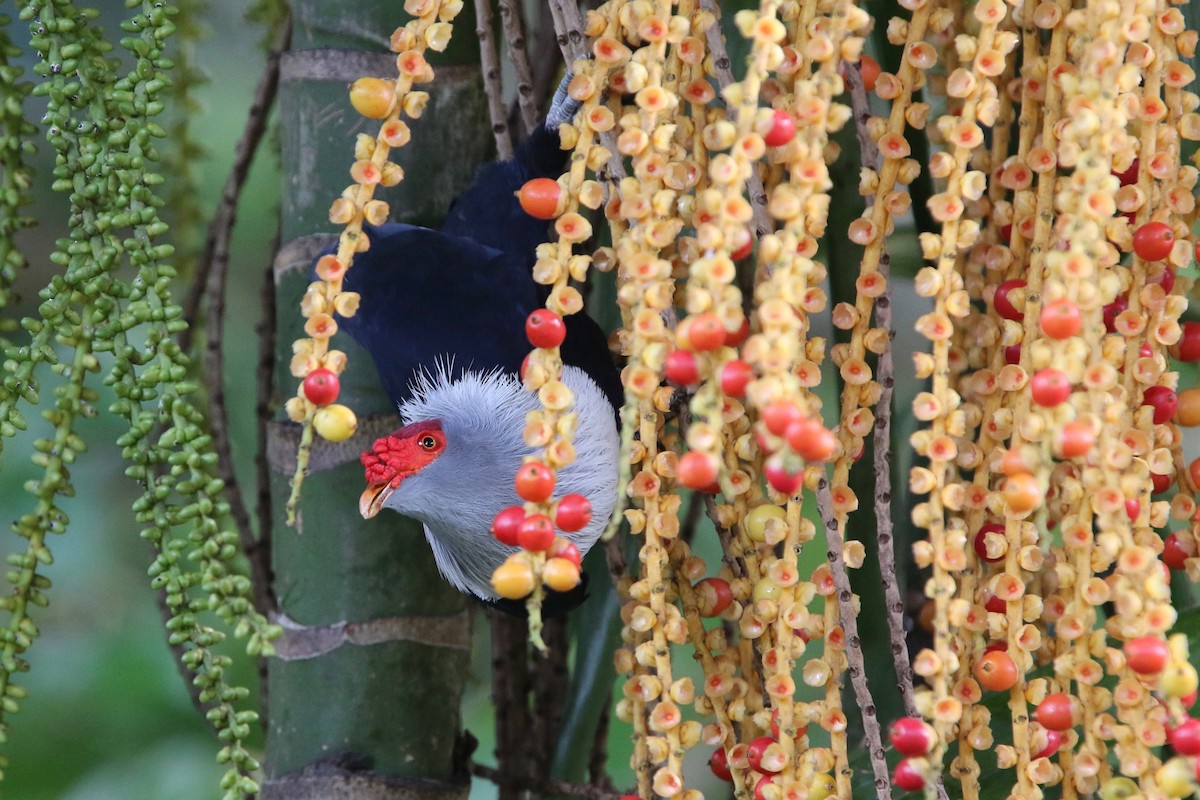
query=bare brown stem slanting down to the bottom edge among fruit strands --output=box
[817,476,892,798]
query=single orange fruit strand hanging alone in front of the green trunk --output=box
[286,0,462,524]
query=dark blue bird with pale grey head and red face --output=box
[338,82,622,612]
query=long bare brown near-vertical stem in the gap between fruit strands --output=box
[845,64,917,716]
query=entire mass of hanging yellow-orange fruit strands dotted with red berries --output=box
[298,0,1200,800]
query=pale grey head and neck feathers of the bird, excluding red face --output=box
[385,367,619,599]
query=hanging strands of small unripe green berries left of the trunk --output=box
[0,0,280,799]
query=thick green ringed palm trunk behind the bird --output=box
[263,1,491,800]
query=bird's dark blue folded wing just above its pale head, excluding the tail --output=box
[328,223,541,403]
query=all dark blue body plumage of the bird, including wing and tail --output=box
[324,116,623,417]
